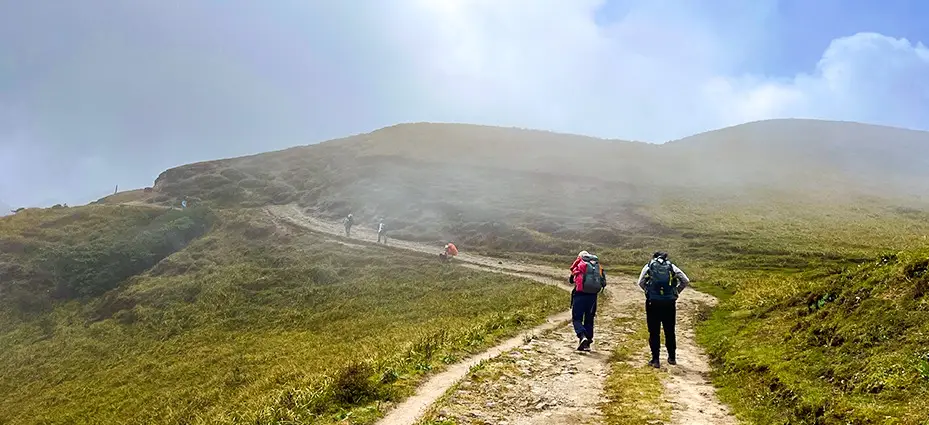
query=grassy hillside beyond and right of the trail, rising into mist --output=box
[136,120,929,424]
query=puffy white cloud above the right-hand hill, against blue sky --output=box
[715,33,929,128]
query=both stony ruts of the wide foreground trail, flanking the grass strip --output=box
[416,279,737,425]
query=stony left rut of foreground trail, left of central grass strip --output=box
[431,278,639,425]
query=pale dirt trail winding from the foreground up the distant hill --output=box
[266,205,737,425]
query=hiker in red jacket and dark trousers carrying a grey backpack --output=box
[571,251,606,351]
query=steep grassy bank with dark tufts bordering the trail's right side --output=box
[698,250,929,424]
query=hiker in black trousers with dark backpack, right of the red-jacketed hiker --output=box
[639,251,690,368]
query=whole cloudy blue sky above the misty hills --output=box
[0,0,929,206]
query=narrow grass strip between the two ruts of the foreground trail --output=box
[602,317,671,425]
